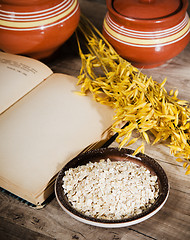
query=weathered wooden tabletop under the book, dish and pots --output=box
[0,0,190,240]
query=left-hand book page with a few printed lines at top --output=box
[0,52,52,114]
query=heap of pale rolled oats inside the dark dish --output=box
[63,159,159,220]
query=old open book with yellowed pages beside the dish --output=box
[0,52,113,205]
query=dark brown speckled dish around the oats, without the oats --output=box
[55,148,169,228]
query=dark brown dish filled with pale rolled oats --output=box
[55,148,169,228]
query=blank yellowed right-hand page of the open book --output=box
[0,74,113,204]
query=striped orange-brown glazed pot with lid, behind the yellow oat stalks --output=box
[103,0,190,68]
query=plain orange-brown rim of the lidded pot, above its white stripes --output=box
[106,0,188,25]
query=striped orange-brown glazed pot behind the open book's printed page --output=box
[0,0,80,59]
